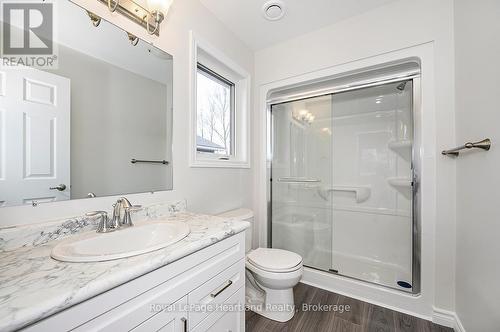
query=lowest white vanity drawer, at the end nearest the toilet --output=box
[191,287,245,332]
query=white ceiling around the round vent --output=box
[200,0,395,50]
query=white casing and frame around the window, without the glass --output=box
[189,31,251,168]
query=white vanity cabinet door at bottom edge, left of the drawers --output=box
[131,296,188,332]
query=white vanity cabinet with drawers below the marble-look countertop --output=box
[23,232,245,332]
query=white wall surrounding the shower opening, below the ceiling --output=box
[254,0,455,317]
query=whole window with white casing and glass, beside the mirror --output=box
[189,32,250,168]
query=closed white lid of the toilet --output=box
[247,248,302,272]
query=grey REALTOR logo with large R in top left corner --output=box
[1,1,57,68]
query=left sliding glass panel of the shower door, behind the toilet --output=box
[271,96,333,270]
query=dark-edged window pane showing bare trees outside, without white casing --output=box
[196,63,235,159]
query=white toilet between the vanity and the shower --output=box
[219,209,303,322]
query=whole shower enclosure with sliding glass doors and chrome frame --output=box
[269,64,420,293]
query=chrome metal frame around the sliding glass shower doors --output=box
[266,70,422,295]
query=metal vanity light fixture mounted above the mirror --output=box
[96,0,172,36]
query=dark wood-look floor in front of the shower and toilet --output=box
[246,283,453,332]
